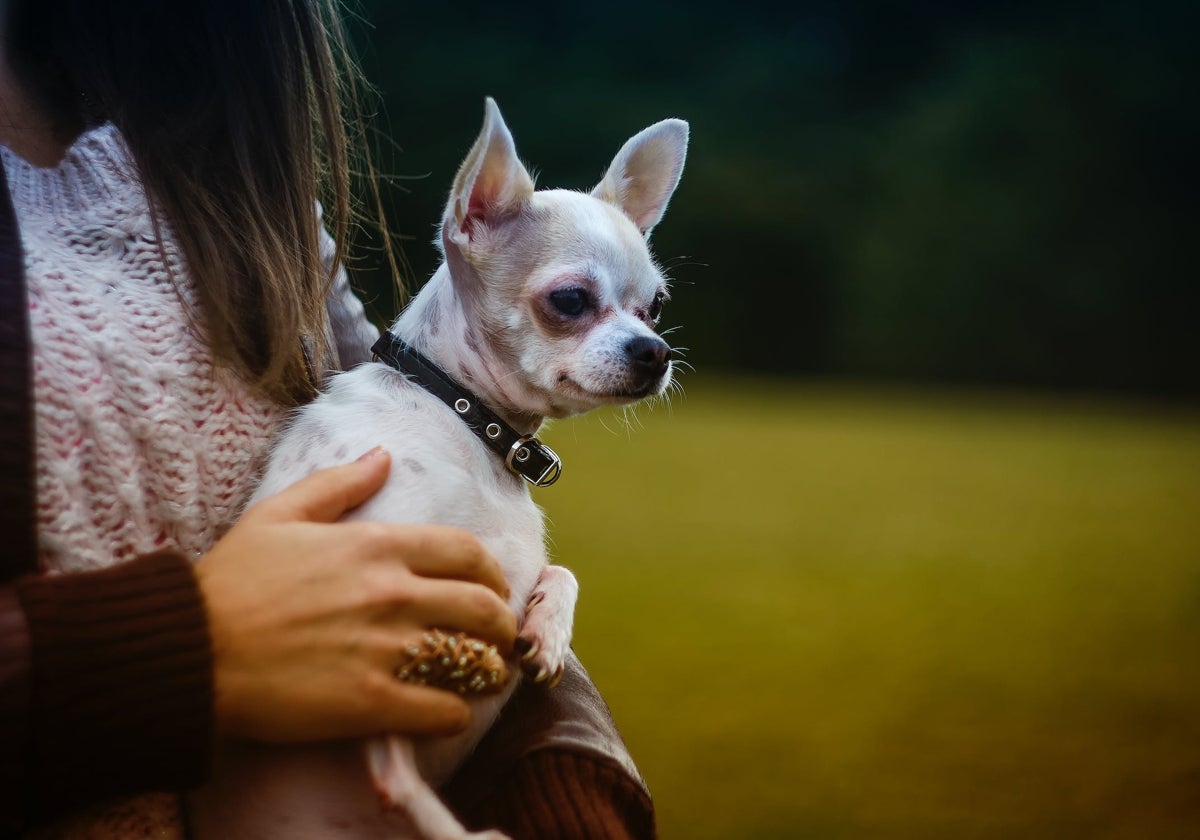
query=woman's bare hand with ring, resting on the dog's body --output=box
[196,449,516,742]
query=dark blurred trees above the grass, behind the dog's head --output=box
[355,0,1200,400]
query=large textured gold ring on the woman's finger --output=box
[396,630,508,695]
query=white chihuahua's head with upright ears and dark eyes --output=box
[442,100,688,416]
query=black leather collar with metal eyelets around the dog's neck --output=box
[371,331,563,487]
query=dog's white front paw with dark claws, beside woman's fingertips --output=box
[514,566,580,688]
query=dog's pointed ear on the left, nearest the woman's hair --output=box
[442,96,533,246]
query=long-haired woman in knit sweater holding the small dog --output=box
[0,0,653,838]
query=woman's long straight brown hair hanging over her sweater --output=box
[6,0,398,403]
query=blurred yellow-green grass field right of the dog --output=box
[538,380,1200,840]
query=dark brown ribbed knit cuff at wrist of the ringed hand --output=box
[16,553,214,821]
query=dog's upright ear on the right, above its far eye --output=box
[592,120,688,236]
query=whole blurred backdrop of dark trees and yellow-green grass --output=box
[345,0,1200,840]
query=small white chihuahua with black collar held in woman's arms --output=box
[190,100,688,840]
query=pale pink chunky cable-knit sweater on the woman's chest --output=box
[0,125,376,571]
